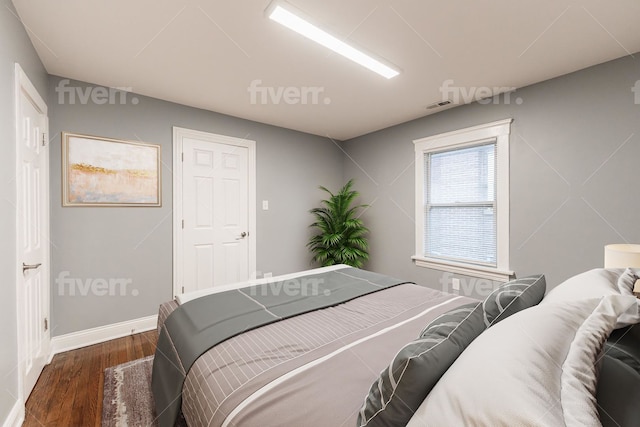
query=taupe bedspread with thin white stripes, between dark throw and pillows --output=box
[159,274,472,427]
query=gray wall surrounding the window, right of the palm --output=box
[343,53,640,296]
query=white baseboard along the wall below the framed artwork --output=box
[49,314,158,361]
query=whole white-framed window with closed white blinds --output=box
[413,119,513,280]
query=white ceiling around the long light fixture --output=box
[13,0,640,140]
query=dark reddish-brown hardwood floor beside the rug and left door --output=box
[23,330,158,427]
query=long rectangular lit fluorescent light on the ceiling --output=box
[269,4,400,79]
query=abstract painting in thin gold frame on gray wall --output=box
[62,132,162,206]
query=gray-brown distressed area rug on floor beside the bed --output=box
[102,356,187,427]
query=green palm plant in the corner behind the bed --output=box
[307,179,369,268]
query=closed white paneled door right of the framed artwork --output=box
[178,129,255,292]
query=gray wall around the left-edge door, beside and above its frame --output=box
[0,0,47,423]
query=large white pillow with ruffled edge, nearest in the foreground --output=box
[408,295,640,427]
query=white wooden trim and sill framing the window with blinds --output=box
[412,119,513,282]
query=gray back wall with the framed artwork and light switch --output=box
[49,76,342,336]
